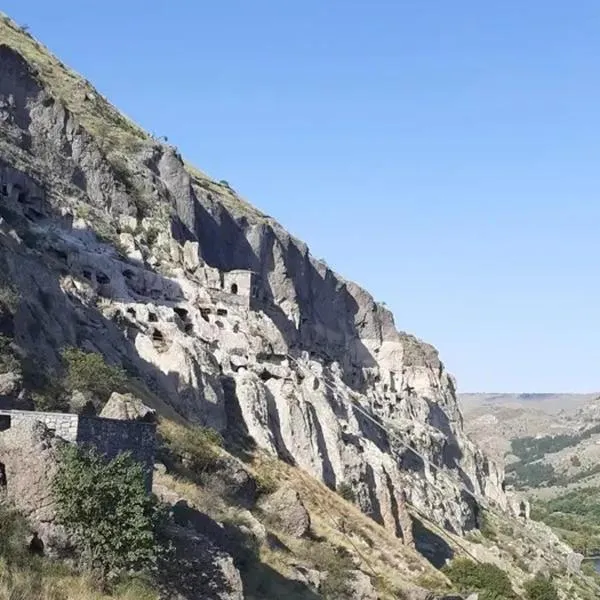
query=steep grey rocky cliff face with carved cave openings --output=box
[0,15,506,534]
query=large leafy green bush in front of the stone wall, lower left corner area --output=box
[53,446,161,581]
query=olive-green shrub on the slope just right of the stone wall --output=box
[159,422,223,478]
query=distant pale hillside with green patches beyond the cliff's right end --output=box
[460,394,600,497]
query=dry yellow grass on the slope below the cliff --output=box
[155,440,448,599]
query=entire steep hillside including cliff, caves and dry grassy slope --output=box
[0,12,597,600]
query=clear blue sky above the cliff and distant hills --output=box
[0,0,600,392]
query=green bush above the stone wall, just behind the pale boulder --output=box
[62,348,127,402]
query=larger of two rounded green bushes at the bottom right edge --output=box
[442,558,517,600]
